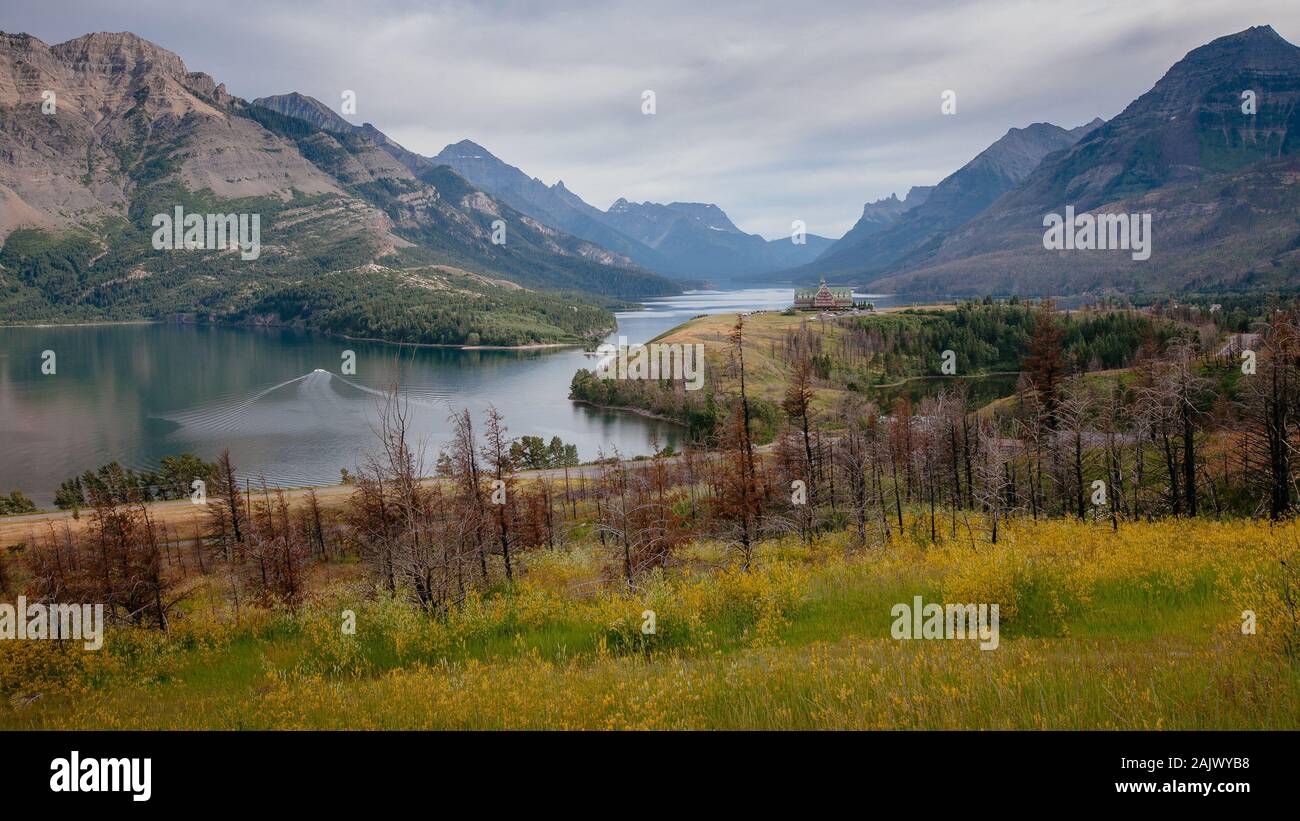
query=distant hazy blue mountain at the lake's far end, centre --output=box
[605,197,832,282]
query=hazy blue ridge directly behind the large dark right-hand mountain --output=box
[800,120,1101,282]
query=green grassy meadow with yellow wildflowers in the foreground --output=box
[0,517,1300,729]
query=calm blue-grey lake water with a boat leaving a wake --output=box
[0,288,889,507]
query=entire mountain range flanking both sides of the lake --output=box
[0,26,1300,344]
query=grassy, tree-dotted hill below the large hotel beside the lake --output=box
[569,300,1182,440]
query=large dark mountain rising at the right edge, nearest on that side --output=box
[876,26,1300,294]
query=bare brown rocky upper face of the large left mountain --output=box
[0,32,351,235]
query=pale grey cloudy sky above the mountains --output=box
[10,0,1300,238]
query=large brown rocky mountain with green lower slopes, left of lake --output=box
[0,32,679,344]
